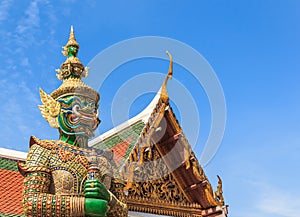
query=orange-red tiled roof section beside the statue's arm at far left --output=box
[0,169,24,214]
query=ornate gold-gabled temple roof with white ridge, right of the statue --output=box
[89,72,227,216]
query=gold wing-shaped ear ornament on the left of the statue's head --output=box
[39,88,61,128]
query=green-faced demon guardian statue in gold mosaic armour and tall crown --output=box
[19,28,128,217]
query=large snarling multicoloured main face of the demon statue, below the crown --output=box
[57,96,100,137]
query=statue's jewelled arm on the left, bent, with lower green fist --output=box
[19,144,107,217]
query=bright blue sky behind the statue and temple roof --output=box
[0,0,300,217]
